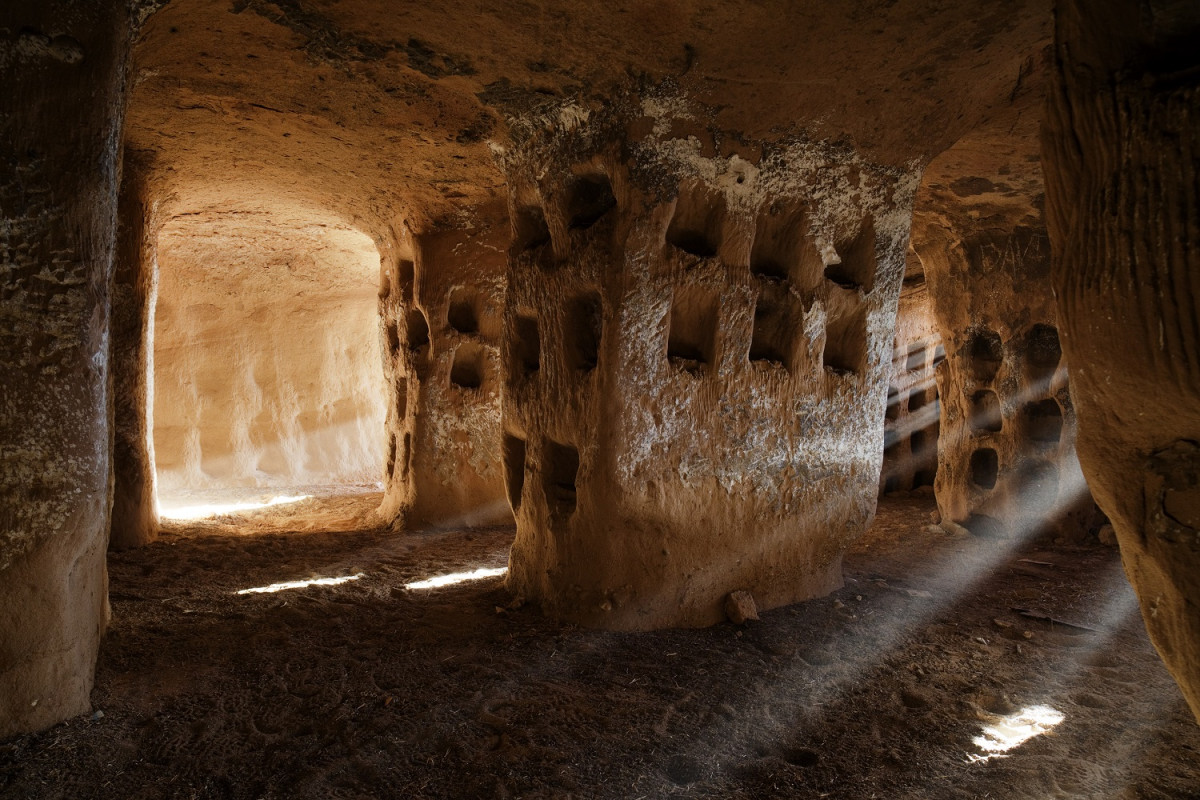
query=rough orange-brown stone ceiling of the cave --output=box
[127,0,1050,237]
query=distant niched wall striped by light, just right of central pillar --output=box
[881,341,946,493]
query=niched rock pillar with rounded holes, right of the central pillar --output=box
[917,229,1096,537]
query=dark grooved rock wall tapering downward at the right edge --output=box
[1044,1,1200,716]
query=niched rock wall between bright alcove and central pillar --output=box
[380,221,511,528]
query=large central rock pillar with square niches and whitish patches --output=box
[503,97,916,628]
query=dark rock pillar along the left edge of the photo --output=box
[0,0,128,736]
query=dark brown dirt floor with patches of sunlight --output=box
[0,494,1200,799]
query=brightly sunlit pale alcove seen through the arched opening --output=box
[151,212,386,519]
